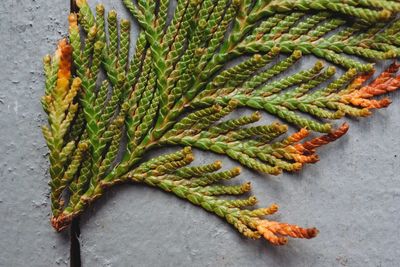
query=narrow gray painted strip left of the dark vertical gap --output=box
[0,0,69,267]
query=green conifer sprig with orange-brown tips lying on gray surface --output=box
[42,0,400,248]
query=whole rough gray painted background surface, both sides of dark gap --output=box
[0,0,400,266]
